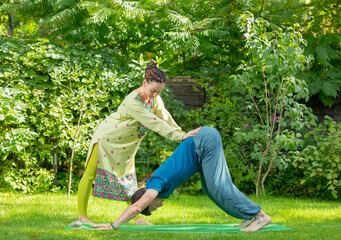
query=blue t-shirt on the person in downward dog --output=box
[146,137,199,199]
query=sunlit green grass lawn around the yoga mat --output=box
[0,193,341,240]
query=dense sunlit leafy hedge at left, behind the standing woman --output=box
[0,38,138,192]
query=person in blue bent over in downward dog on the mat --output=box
[93,127,271,232]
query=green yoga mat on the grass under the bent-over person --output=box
[64,224,292,233]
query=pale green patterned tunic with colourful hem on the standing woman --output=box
[87,91,184,201]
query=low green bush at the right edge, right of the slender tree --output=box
[290,117,341,199]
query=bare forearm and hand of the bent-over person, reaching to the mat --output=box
[92,189,159,230]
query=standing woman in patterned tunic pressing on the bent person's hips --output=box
[78,62,198,224]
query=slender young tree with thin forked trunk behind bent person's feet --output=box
[232,13,314,195]
